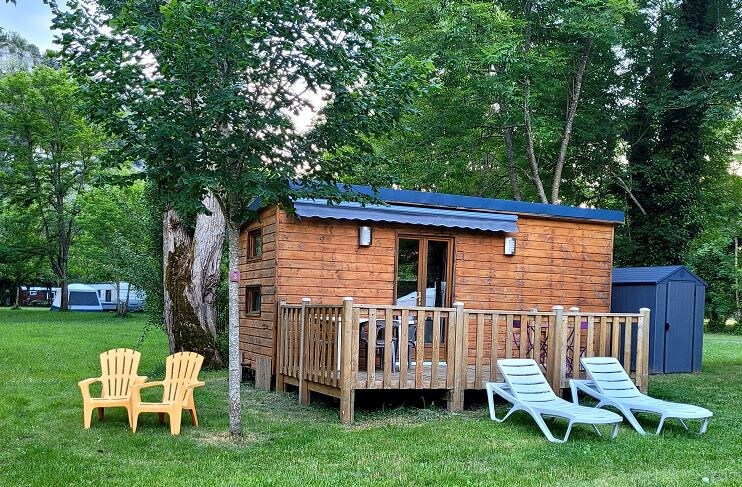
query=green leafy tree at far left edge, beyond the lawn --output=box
[0,67,104,310]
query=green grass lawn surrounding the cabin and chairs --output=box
[0,309,742,486]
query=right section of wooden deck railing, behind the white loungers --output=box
[459,306,649,392]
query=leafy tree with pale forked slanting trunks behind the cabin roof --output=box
[374,0,631,203]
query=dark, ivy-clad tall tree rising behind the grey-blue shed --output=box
[617,0,742,265]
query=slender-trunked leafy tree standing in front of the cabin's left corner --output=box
[56,0,428,434]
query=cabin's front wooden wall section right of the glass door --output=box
[454,216,613,312]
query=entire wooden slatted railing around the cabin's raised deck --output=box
[276,298,649,422]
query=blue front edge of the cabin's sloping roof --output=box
[353,186,624,223]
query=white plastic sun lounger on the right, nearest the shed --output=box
[570,357,713,435]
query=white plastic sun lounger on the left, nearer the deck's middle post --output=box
[485,359,622,443]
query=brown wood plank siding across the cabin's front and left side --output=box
[240,209,614,367]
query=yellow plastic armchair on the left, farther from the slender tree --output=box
[77,348,147,429]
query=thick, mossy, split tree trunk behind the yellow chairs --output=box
[162,195,224,368]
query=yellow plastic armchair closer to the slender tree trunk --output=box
[131,352,204,435]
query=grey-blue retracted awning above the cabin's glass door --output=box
[294,200,518,233]
